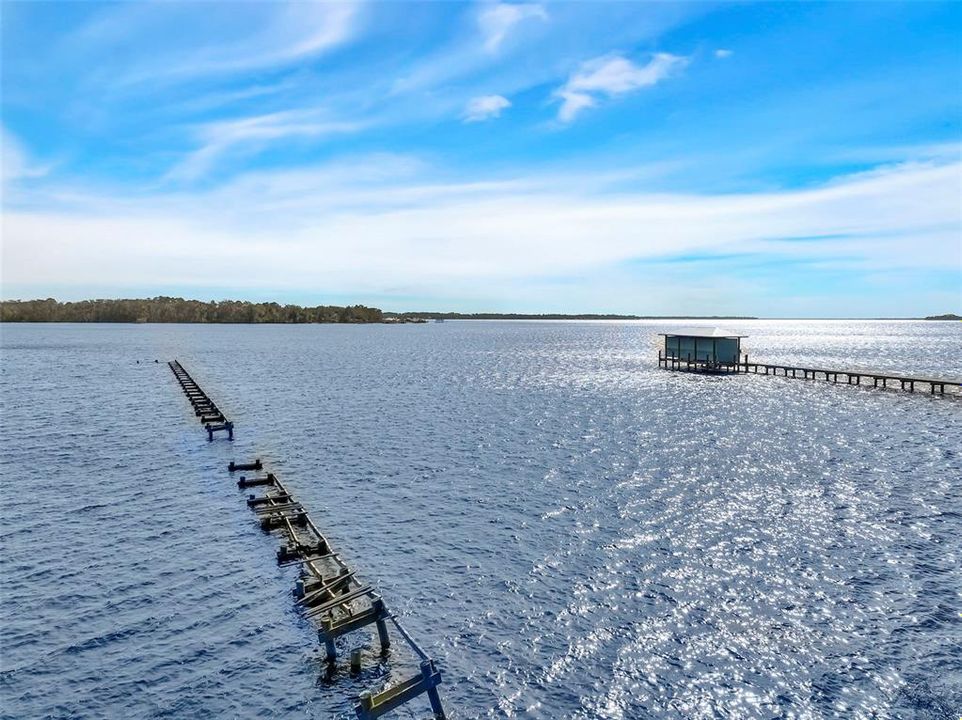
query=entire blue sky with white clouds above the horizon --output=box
[2,2,962,317]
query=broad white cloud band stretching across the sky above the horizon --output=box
[3,157,962,296]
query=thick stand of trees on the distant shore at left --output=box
[0,297,384,323]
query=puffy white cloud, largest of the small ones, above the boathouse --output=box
[555,53,688,122]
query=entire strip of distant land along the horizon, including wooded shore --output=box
[0,296,962,324]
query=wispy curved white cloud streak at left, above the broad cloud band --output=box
[167,110,363,180]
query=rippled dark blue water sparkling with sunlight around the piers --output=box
[0,322,962,720]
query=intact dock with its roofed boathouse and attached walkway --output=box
[658,328,962,395]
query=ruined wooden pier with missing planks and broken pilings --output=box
[169,360,445,720]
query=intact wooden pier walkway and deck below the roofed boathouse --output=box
[658,350,962,395]
